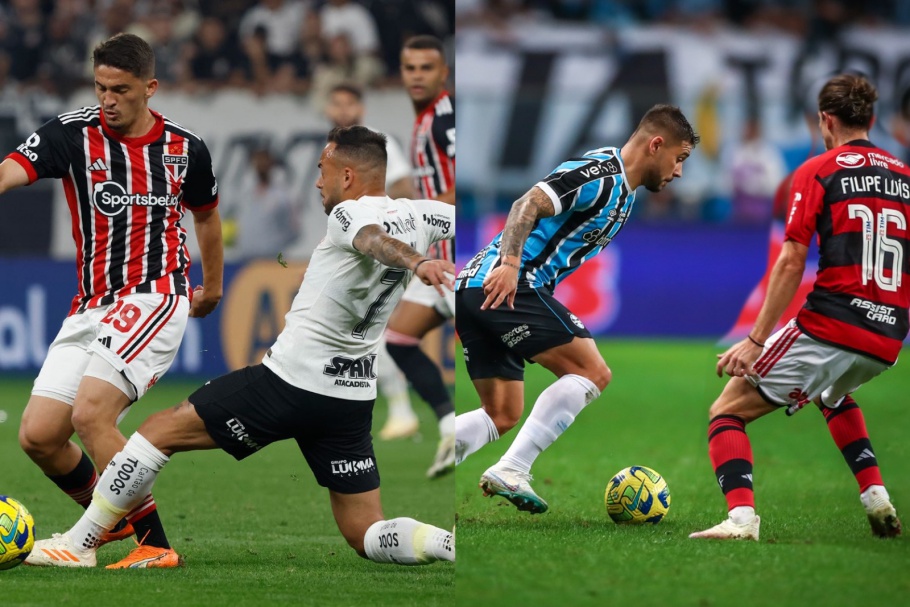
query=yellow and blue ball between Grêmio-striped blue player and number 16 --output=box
[604,466,670,524]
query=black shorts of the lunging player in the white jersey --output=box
[188,365,379,493]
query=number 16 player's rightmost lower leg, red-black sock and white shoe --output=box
[820,395,901,537]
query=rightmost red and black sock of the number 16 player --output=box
[821,395,885,493]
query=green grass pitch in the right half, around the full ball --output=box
[456,340,910,607]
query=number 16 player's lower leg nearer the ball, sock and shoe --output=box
[689,415,761,541]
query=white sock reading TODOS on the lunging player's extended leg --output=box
[67,432,168,550]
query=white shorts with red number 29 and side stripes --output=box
[32,293,190,405]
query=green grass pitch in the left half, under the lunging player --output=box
[0,378,455,607]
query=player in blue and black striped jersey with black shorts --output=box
[455,105,699,513]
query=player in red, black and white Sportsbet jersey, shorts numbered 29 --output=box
[0,34,223,567]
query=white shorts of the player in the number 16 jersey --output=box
[747,320,891,408]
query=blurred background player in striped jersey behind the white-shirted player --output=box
[383,36,455,478]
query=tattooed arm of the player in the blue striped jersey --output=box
[480,186,556,310]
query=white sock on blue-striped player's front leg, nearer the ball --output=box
[499,374,600,473]
